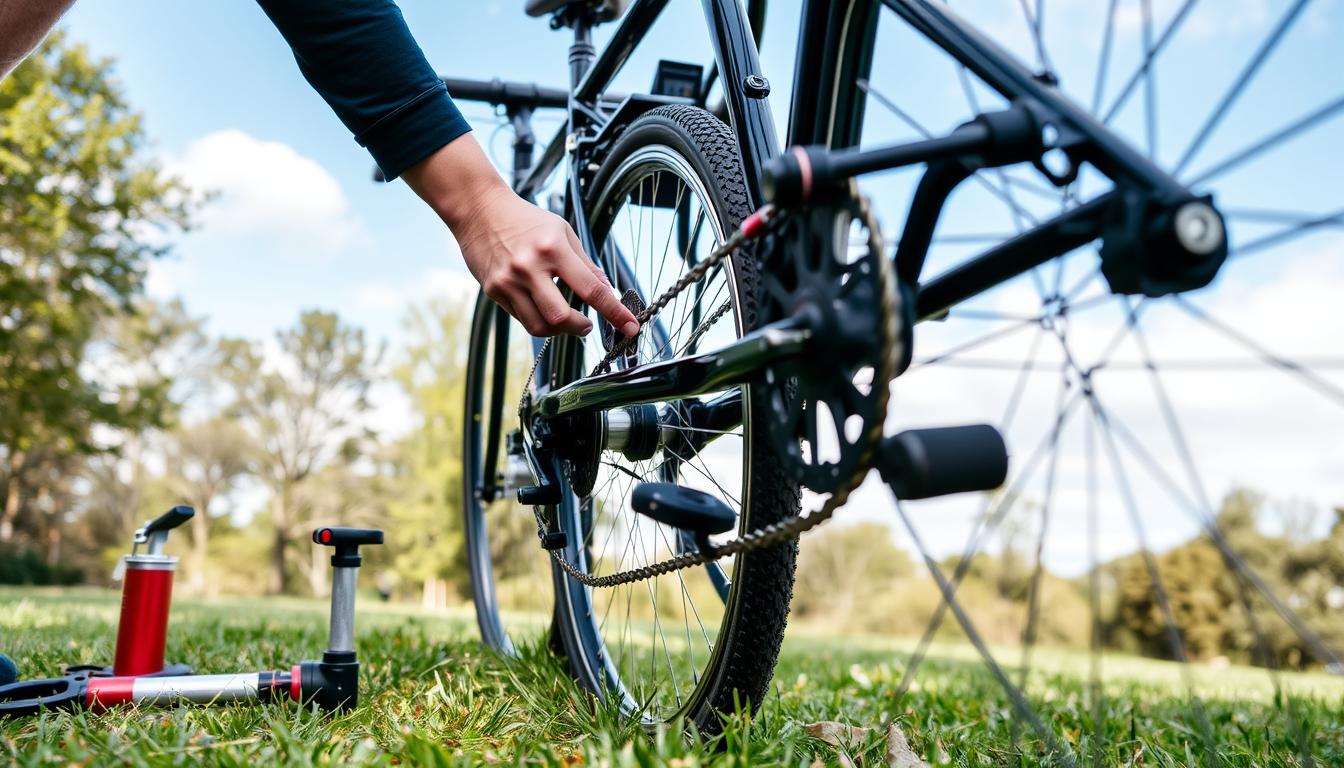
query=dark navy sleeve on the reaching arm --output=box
[258,0,470,180]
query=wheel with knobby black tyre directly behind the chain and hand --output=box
[552,106,798,734]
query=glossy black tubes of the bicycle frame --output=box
[475,0,1220,416]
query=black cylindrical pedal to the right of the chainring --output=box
[878,424,1008,499]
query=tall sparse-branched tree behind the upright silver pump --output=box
[219,309,382,593]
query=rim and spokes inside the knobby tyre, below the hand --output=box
[548,144,751,724]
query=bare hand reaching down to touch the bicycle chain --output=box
[403,135,640,336]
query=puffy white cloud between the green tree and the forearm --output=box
[165,129,367,254]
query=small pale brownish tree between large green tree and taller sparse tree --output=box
[165,417,254,592]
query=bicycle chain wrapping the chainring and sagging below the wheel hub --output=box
[534,195,902,589]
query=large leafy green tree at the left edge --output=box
[0,34,188,551]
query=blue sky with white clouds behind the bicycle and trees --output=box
[63,0,1344,570]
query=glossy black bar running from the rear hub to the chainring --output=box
[535,319,810,418]
